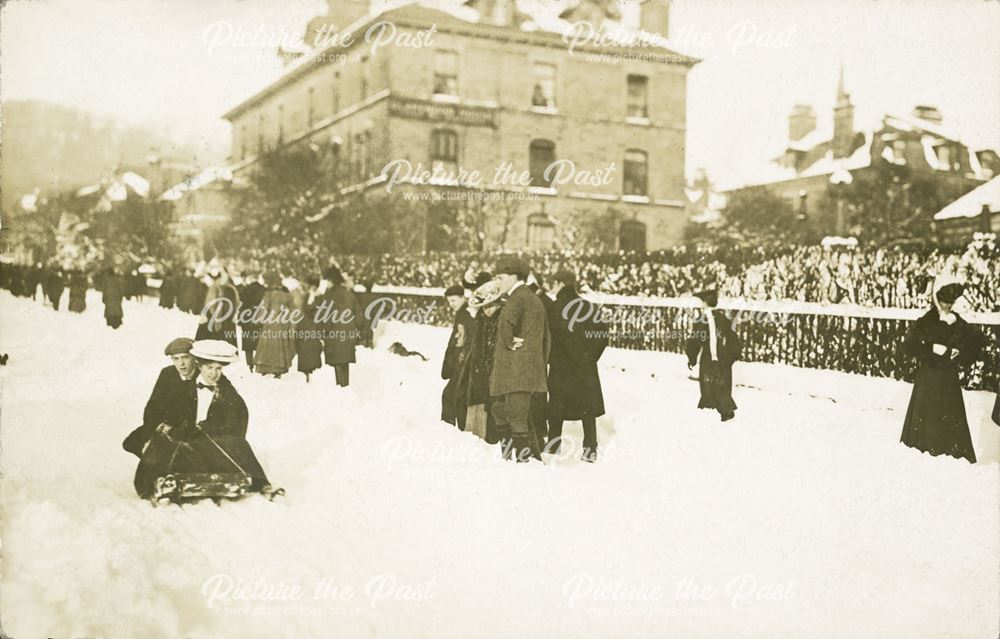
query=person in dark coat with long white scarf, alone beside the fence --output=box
[686,289,740,422]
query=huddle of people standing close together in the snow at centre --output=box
[441,256,608,462]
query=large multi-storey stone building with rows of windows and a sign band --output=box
[224,0,697,250]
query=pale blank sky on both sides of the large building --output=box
[0,0,1000,187]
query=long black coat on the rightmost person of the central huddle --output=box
[548,286,608,420]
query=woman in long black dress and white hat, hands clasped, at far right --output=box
[900,280,983,463]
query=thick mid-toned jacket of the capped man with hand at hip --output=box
[490,285,550,397]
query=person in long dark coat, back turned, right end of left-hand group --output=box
[320,266,365,386]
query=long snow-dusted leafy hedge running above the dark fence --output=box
[217,235,1000,312]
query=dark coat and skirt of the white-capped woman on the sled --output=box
[134,376,268,497]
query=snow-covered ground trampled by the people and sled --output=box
[0,292,1000,639]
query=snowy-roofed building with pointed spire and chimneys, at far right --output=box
[733,70,1000,235]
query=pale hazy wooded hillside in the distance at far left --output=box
[0,100,225,210]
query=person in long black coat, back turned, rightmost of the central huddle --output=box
[546,271,608,462]
